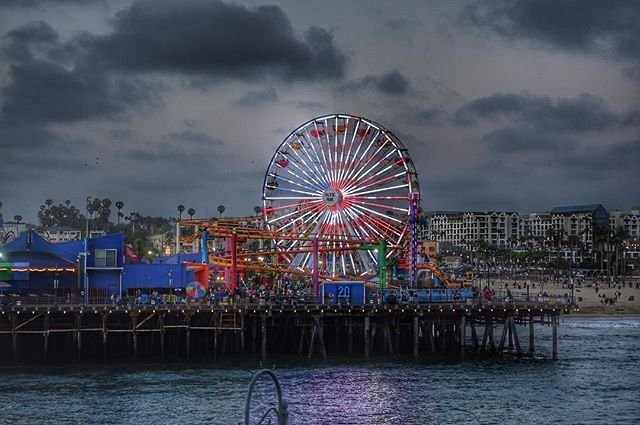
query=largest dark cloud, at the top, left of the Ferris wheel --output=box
[74,0,347,80]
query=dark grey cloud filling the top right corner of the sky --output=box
[460,0,640,61]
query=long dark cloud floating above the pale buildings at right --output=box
[452,93,620,133]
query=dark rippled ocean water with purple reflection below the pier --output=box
[0,316,640,425]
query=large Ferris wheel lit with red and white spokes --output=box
[262,114,419,276]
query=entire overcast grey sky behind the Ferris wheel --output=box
[0,0,640,221]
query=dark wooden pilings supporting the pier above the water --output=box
[0,304,569,362]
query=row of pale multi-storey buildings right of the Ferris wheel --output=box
[418,204,640,262]
